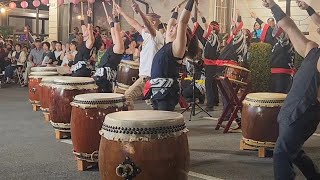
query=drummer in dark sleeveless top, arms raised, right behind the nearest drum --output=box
[150,0,199,111]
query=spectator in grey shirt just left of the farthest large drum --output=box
[22,38,44,87]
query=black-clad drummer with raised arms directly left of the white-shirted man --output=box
[93,8,125,93]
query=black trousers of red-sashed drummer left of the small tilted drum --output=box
[205,66,219,108]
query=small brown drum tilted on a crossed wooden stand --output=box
[224,64,250,85]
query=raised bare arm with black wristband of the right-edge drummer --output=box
[262,0,318,57]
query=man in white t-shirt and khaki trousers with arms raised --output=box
[117,2,164,110]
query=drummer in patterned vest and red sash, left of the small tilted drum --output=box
[192,11,220,111]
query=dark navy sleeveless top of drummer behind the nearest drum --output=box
[151,42,180,79]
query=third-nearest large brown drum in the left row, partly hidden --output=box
[49,77,97,132]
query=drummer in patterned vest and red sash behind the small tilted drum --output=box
[218,10,251,129]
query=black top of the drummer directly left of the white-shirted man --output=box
[98,45,123,70]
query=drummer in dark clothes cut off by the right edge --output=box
[262,0,320,180]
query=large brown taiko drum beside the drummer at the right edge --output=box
[241,93,287,147]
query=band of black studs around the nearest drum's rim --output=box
[102,123,186,134]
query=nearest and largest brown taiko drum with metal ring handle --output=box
[99,110,190,180]
